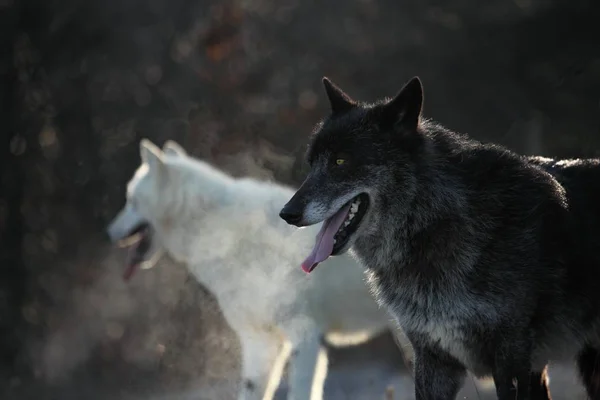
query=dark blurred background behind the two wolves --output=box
[0,0,600,399]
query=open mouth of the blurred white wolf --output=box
[119,222,156,280]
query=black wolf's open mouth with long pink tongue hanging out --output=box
[302,193,369,273]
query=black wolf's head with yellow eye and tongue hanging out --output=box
[280,77,426,272]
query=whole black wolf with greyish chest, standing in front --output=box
[281,79,600,400]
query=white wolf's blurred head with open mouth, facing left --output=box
[107,139,228,279]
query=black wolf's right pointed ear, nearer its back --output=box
[384,76,423,129]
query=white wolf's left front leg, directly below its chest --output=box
[238,334,291,400]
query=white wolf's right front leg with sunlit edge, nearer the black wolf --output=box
[288,330,327,400]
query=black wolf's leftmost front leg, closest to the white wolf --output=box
[413,343,467,400]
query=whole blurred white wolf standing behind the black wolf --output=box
[108,139,410,400]
